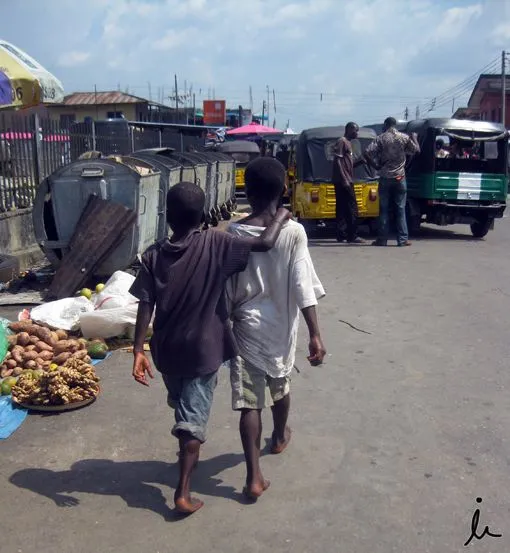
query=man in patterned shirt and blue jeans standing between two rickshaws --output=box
[365,117,420,246]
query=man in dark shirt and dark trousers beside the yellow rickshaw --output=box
[331,122,364,244]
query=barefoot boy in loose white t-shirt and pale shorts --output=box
[226,157,326,499]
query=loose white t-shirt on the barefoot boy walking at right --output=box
[226,220,325,378]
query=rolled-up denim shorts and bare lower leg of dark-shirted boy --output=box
[164,372,218,513]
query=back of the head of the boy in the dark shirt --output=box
[166,182,205,228]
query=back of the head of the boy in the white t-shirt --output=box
[244,157,285,201]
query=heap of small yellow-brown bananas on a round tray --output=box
[12,358,99,405]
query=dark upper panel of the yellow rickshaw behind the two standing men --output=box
[302,138,376,182]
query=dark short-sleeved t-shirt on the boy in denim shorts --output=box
[130,230,251,378]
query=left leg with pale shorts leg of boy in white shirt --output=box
[230,357,269,499]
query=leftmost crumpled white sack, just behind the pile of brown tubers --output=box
[30,296,94,330]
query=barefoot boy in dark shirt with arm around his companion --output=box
[130,182,291,513]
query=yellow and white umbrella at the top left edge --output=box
[0,40,64,108]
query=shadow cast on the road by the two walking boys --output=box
[9,453,244,521]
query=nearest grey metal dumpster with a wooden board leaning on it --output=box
[33,158,160,276]
